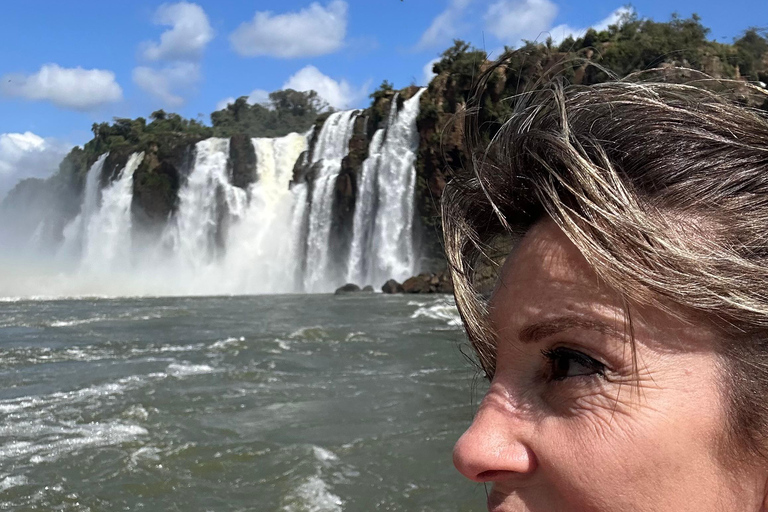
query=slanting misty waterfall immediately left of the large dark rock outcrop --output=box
[81,153,144,276]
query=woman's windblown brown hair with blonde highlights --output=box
[442,70,768,454]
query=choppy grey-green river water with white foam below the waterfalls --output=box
[0,294,485,512]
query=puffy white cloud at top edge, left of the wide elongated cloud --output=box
[142,2,213,61]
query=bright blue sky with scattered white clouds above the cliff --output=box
[0,0,768,197]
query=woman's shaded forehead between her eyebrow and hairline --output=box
[489,219,714,351]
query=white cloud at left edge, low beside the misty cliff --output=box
[0,132,70,199]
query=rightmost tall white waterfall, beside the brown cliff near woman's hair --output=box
[347,89,425,286]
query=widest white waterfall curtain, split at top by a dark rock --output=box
[142,133,307,295]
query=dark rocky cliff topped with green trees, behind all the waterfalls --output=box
[0,16,768,290]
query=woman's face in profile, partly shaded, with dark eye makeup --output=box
[454,221,766,512]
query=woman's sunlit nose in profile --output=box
[453,397,537,482]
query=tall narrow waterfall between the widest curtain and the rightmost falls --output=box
[304,110,359,292]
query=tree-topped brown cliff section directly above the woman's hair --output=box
[412,13,768,264]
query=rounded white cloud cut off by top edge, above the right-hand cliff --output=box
[485,0,558,47]
